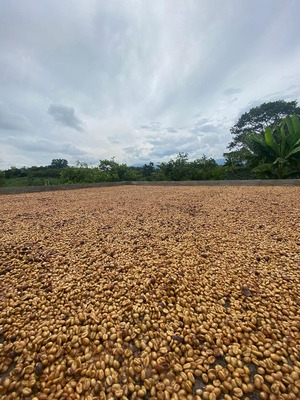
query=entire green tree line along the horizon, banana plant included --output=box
[0,100,300,186]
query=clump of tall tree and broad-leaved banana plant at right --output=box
[224,100,300,179]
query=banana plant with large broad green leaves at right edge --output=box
[246,114,300,179]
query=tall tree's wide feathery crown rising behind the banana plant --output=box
[228,100,300,150]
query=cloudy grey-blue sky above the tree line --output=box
[0,0,300,169]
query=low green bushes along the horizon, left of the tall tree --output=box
[0,153,226,186]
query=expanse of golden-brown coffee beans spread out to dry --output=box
[0,186,300,400]
